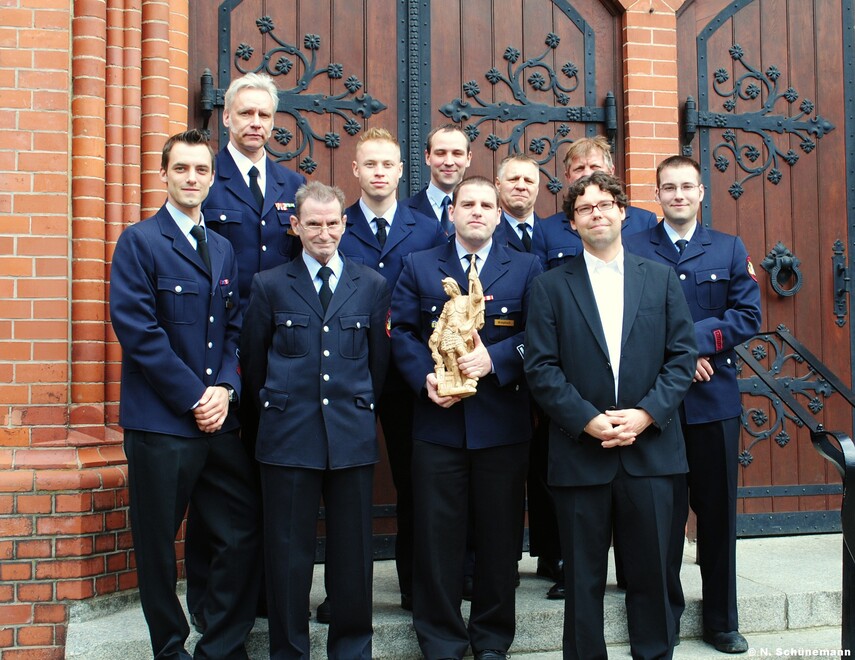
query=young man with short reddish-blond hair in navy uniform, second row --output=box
[338,128,448,621]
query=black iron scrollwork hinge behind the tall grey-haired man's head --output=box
[214,16,386,174]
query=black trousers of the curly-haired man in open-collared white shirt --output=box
[552,467,676,660]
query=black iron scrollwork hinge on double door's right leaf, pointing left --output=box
[439,32,617,194]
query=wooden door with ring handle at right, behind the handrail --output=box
[678,0,855,535]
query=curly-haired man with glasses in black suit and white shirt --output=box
[525,173,697,660]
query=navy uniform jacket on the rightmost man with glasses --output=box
[625,219,761,424]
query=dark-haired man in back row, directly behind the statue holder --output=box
[401,124,472,234]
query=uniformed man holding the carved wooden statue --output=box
[392,177,541,660]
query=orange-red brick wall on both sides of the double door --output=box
[0,0,682,660]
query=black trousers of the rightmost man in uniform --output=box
[669,417,740,631]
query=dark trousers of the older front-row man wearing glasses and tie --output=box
[261,463,374,660]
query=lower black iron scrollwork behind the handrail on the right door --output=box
[737,325,835,468]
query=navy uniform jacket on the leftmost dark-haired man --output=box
[110,206,240,437]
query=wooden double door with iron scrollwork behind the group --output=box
[190,0,622,556]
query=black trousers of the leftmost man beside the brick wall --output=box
[125,430,261,660]
